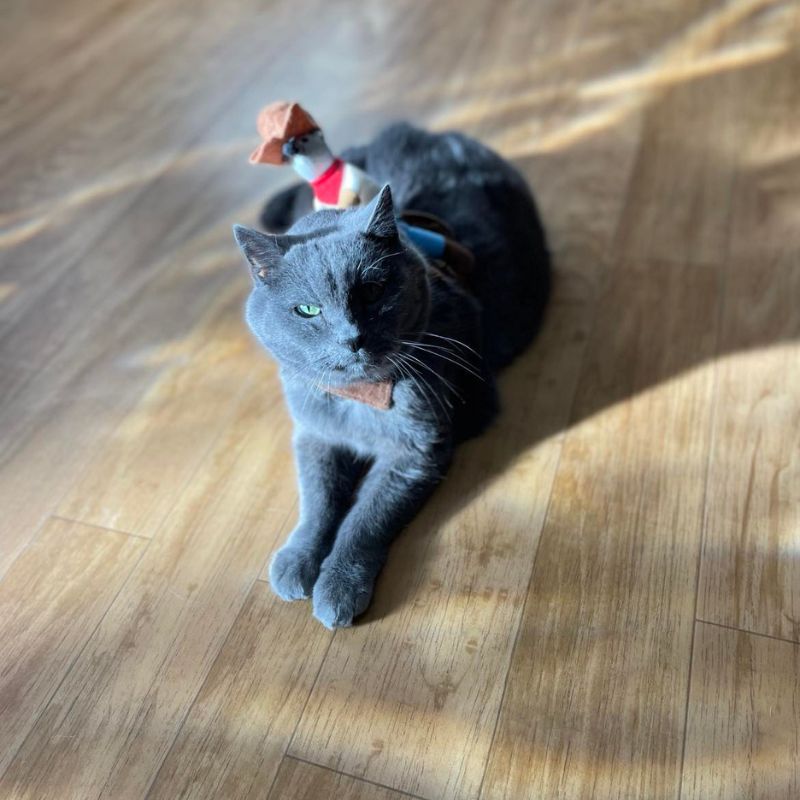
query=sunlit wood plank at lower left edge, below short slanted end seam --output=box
[0,519,146,774]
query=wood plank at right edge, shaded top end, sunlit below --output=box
[698,251,800,641]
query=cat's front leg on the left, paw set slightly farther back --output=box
[269,432,363,600]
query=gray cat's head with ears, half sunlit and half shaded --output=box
[234,186,430,386]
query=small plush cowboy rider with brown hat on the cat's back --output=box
[250,101,473,280]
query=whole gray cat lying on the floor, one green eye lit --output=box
[228,125,550,628]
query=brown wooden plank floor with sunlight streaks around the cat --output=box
[0,0,800,800]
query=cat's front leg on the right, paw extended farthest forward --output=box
[313,452,450,628]
